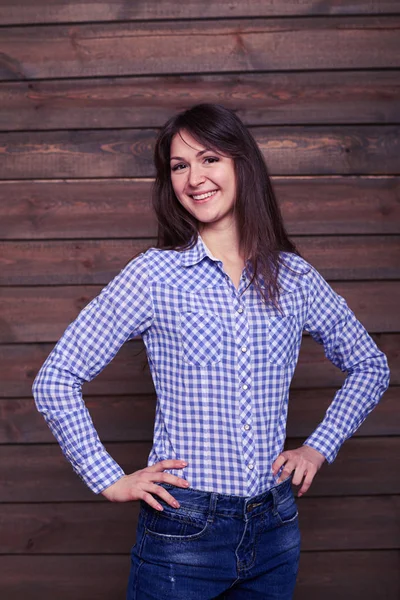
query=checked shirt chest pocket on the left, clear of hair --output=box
[180,311,222,366]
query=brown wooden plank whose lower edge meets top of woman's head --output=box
[0,70,400,131]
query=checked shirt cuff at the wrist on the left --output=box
[65,450,125,494]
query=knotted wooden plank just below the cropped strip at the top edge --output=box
[0,15,400,80]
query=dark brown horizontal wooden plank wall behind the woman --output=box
[0,0,400,600]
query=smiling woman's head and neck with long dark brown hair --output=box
[153,104,298,303]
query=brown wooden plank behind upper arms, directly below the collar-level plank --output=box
[0,281,400,344]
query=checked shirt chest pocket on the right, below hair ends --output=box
[268,315,298,365]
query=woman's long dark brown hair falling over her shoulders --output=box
[153,104,299,305]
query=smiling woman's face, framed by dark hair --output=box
[170,131,236,230]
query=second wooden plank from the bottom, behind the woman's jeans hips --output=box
[0,494,400,555]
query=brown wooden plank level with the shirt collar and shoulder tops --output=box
[0,236,400,288]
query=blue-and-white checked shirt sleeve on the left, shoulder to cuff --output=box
[32,254,153,493]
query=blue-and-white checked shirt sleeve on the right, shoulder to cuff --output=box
[304,268,389,463]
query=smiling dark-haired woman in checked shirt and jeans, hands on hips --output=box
[33,104,388,600]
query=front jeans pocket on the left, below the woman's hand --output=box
[140,503,208,541]
